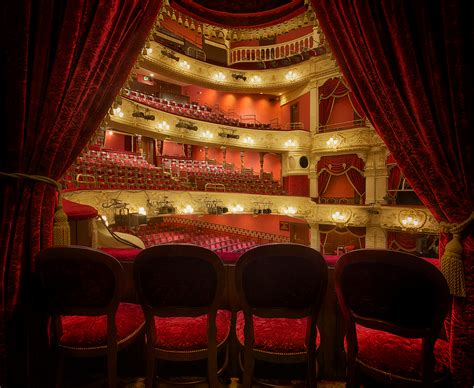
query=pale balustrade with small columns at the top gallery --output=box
[228,32,315,65]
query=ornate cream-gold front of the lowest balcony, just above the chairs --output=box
[63,190,439,233]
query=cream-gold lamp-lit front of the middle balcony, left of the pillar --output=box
[109,98,311,153]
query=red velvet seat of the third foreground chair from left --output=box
[236,311,319,353]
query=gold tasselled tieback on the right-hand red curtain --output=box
[440,212,474,297]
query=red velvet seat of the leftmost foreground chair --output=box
[60,303,145,348]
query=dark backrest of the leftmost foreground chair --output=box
[37,246,123,316]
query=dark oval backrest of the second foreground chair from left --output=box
[134,244,224,316]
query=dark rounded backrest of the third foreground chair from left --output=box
[235,243,328,318]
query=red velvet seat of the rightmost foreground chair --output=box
[345,325,449,380]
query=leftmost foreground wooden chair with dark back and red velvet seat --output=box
[37,246,145,388]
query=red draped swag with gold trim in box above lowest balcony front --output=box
[317,154,365,197]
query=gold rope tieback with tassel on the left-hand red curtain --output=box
[0,171,71,245]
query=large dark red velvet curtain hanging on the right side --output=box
[313,0,474,387]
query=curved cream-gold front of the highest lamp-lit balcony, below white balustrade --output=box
[139,42,338,93]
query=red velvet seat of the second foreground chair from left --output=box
[155,310,231,351]
